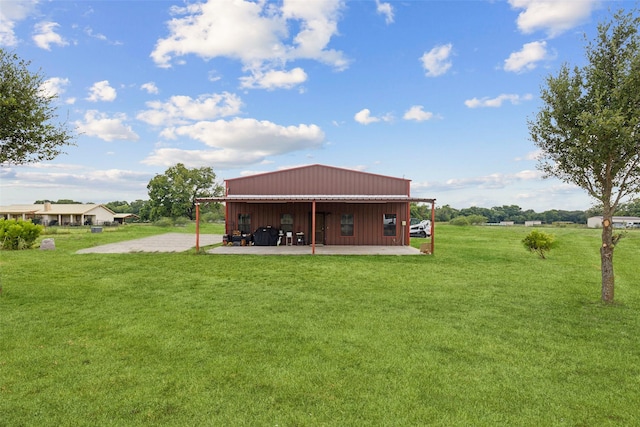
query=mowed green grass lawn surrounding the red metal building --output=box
[0,225,640,426]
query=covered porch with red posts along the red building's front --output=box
[196,195,435,254]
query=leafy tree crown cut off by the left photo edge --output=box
[0,48,75,165]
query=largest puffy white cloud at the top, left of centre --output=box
[151,0,348,89]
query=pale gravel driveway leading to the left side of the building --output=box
[76,233,222,254]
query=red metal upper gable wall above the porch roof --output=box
[226,165,410,196]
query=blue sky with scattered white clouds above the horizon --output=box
[0,0,635,212]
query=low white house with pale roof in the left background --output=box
[0,203,115,226]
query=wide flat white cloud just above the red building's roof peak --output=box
[143,118,324,168]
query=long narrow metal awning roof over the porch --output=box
[196,194,436,203]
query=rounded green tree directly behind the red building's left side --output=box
[147,163,223,220]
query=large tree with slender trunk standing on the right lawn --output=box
[529,11,640,302]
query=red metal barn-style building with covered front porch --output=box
[196,165,435,253]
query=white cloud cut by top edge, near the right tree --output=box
[509,0,601,37]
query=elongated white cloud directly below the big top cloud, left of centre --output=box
[136,92,242,126]
